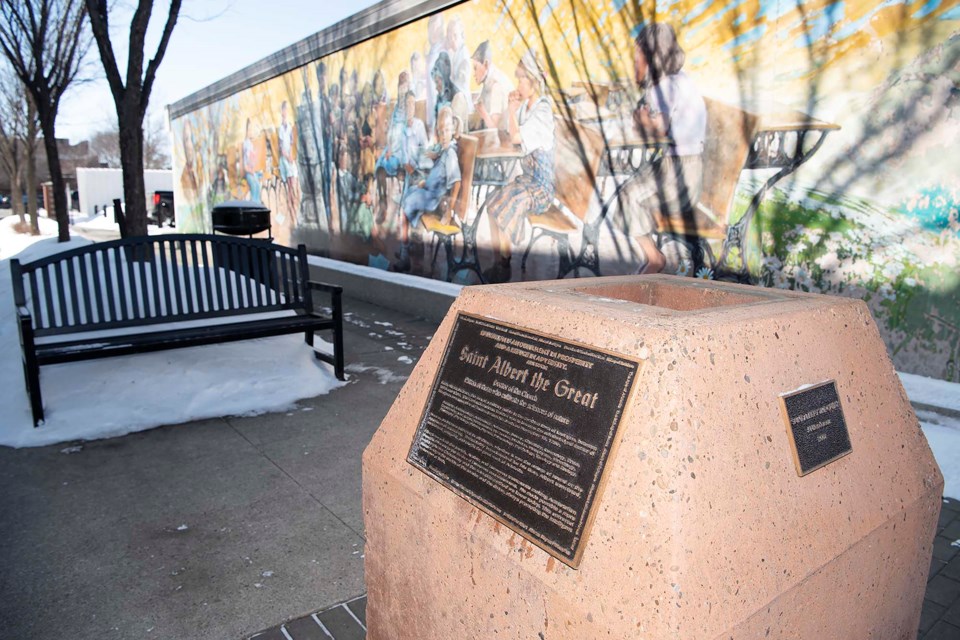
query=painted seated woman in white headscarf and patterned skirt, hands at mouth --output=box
[483,49,555,283]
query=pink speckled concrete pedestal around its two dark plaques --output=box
[363,276,943,640]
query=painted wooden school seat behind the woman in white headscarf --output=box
[520,118,604,278]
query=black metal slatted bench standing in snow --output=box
[10,235,343,425]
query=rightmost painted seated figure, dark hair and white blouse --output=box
[617,23,707,273]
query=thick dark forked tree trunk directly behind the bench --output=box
[86,0,181,236]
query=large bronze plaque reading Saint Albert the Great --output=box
[407,314,638,567]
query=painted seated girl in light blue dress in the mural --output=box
[393,105,461,272]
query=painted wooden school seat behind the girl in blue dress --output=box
[420,134,483,282]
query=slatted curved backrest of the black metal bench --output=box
[11,235,310,337]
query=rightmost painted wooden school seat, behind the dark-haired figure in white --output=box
[657,98,758,270]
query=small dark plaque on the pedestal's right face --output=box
[780,380,852,476]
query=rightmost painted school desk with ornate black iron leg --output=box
[714,107,840,282]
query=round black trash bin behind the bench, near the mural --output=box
[211,200,278,289]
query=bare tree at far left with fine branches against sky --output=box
[0,0,90,242]
